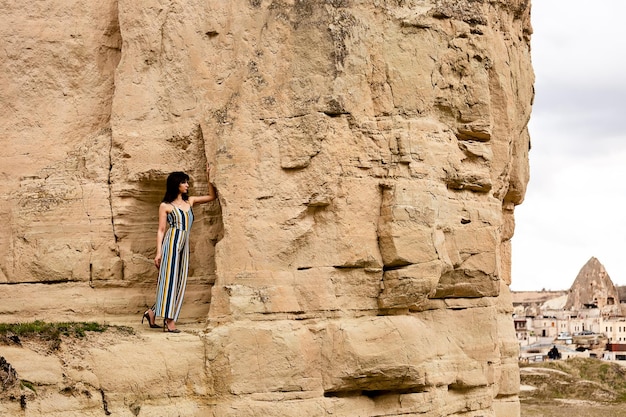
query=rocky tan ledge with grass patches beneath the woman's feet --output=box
[0,318,209,417]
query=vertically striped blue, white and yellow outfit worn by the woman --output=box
[154,204,193,321]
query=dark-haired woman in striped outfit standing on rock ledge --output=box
[141,163,216,333]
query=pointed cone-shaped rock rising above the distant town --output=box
[565,257,621,314]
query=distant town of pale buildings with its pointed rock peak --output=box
[512,257,626,362]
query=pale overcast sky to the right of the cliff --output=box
[511,0,626,291]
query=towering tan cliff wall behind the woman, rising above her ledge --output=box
[0,0,533,417]
